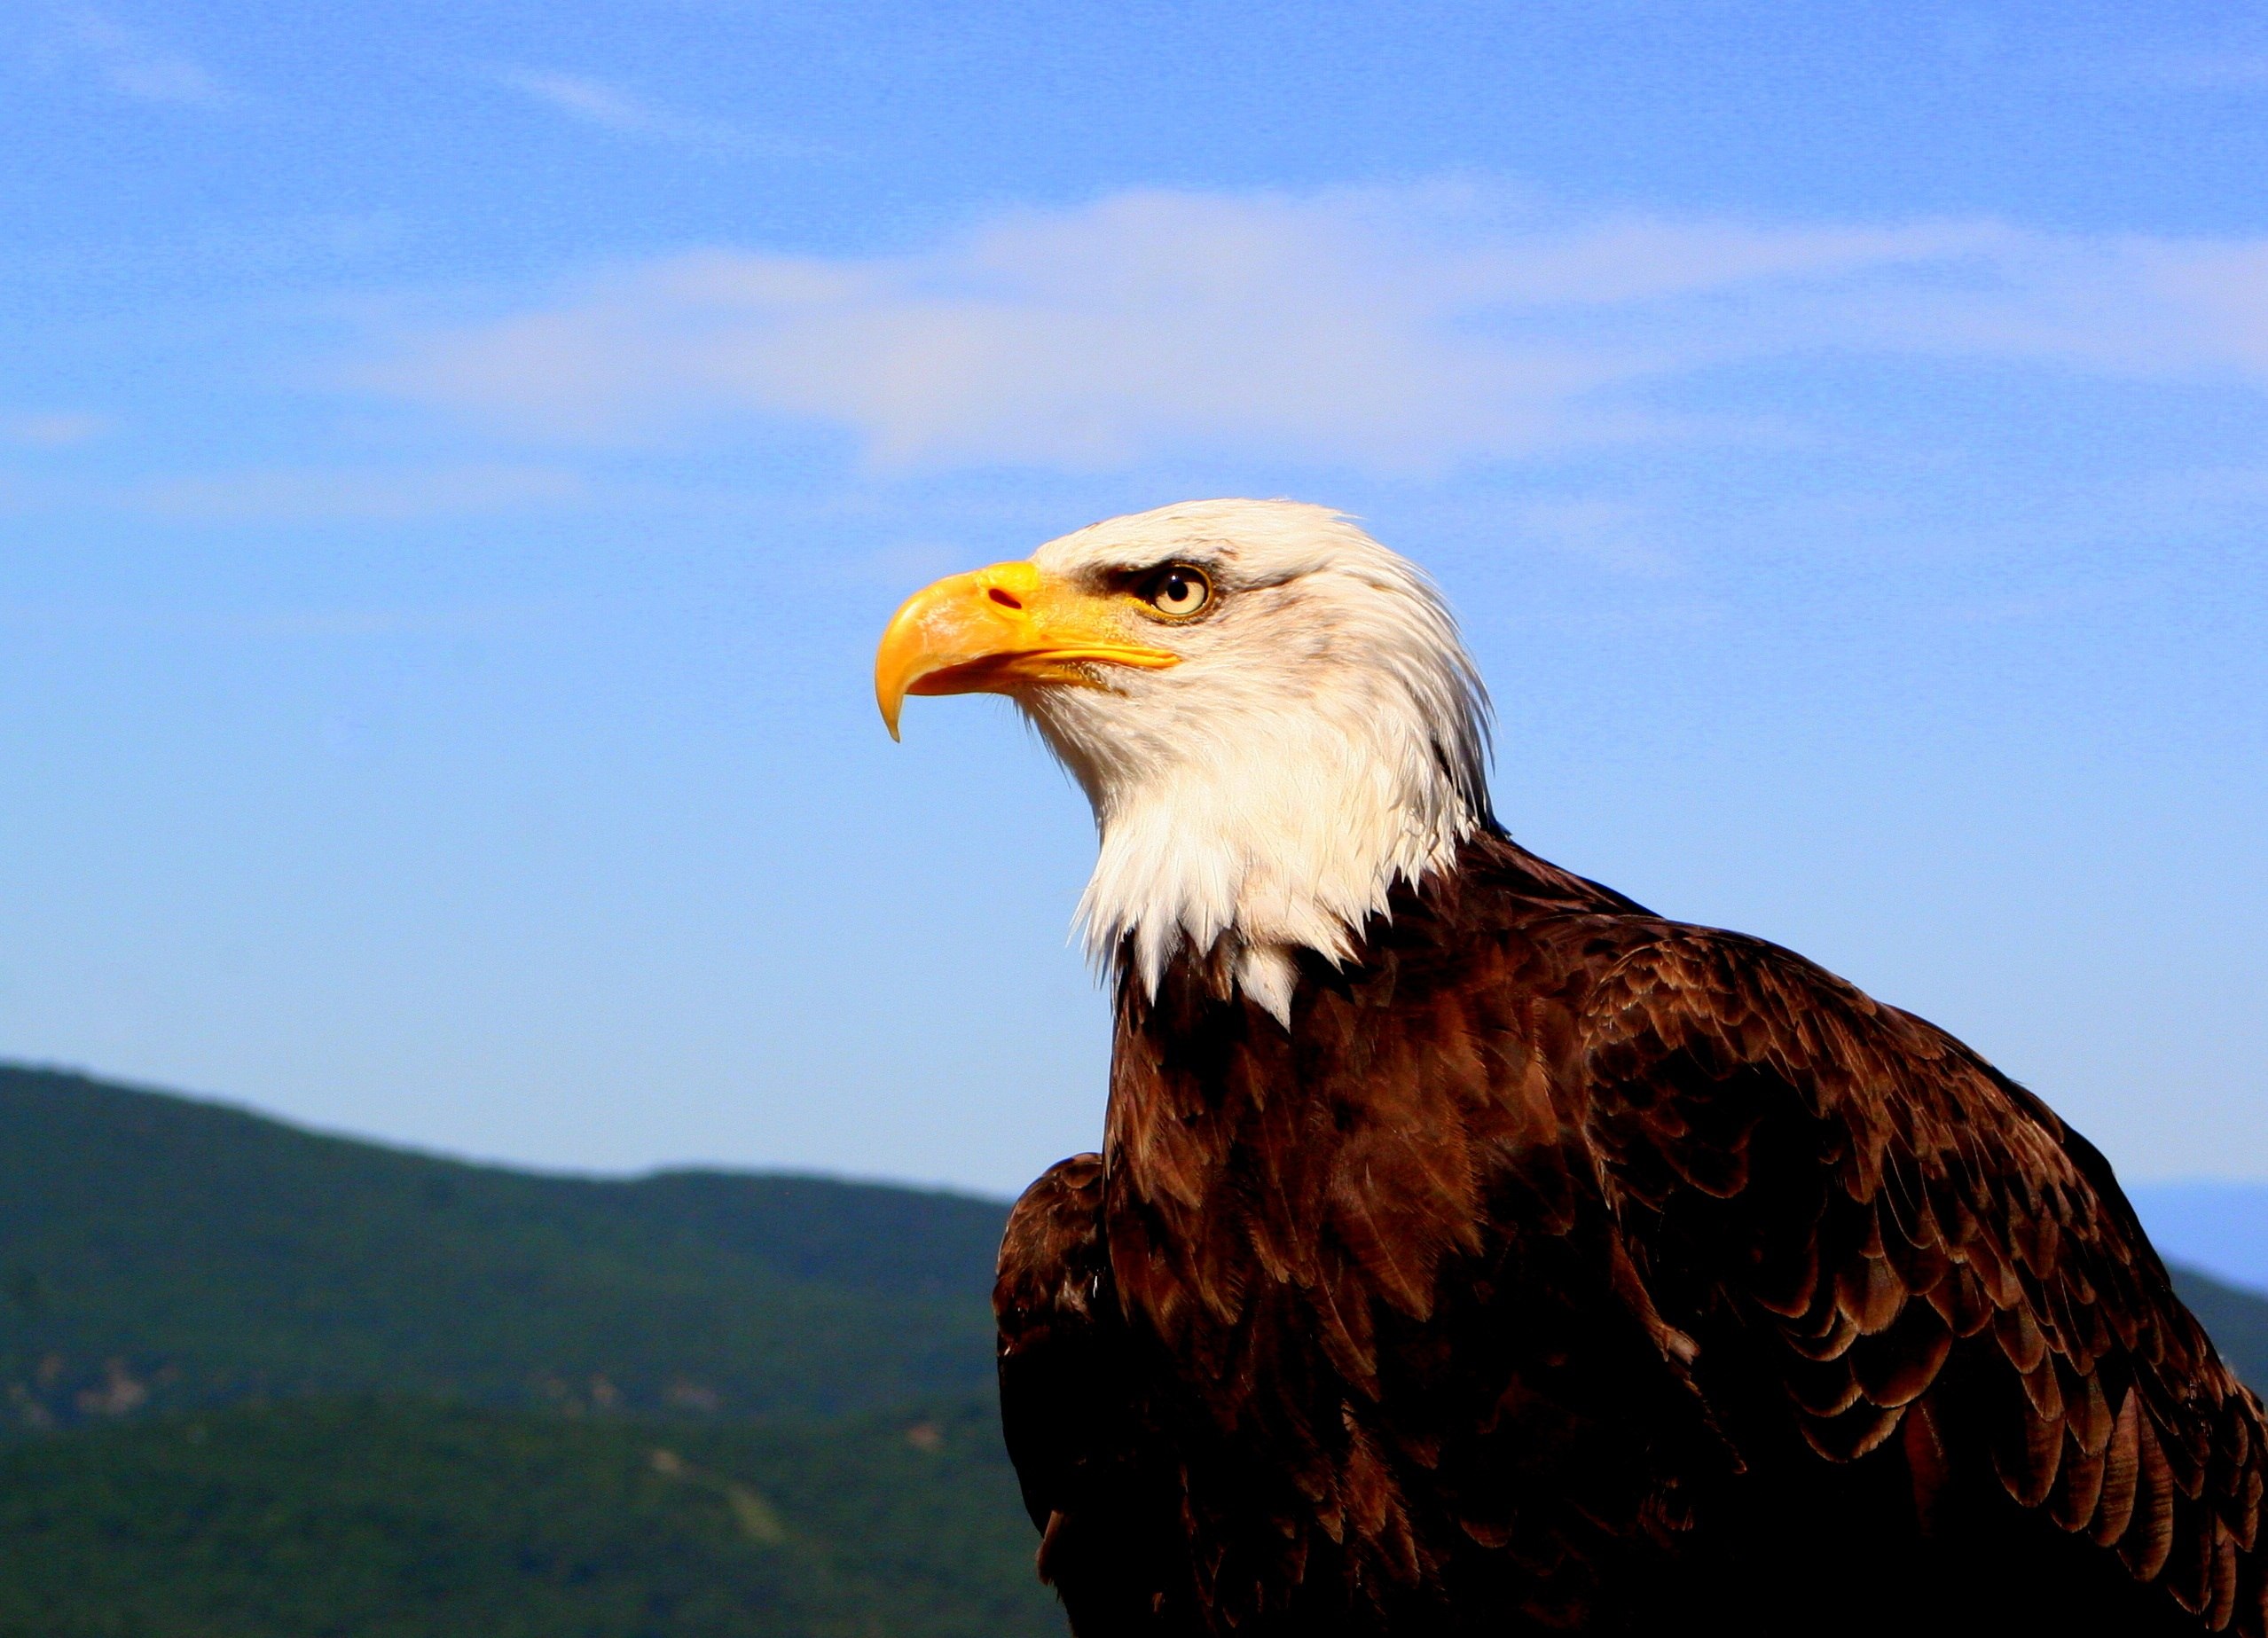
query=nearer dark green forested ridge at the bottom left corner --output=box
[0,1399,1063,1638]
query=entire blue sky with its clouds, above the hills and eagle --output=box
[0,0,2268,1191]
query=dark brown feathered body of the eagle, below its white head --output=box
[996,835,2268,1638]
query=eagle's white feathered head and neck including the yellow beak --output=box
[873,501,1493,1023]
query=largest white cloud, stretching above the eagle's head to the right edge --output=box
[361,188,2268,472]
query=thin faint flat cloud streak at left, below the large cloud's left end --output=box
[136,465,585,524]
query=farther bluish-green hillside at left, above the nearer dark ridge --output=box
[0,1069,1005,1430]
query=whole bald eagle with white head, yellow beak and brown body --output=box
[875,501,2268,1638]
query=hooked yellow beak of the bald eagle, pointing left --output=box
[873,560,1181,740]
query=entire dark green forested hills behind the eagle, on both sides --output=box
[0,1066,2268,1638]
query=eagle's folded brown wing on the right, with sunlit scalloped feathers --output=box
[1576,928,2268,1634]
